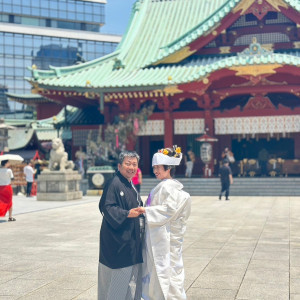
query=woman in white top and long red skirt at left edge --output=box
[0,160,16,221]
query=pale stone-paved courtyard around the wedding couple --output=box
[0,196,300,300]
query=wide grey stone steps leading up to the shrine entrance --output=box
[141,177,300,196]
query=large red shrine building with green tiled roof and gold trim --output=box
[27,0,300,176]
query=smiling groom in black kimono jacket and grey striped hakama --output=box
[98,151,144,300]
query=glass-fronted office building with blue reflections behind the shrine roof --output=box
[0,0,121,110]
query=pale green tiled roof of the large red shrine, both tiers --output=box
[30,0,300,92]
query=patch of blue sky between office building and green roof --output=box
[101,0,136,35]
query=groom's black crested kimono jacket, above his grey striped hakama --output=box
[99,172,143,269]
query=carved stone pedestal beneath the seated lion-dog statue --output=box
[37,171,82,201]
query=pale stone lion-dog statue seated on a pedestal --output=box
[49,138,74,171]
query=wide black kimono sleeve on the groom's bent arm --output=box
[99,180,129,230]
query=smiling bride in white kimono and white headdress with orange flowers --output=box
[139,146,191,300]
